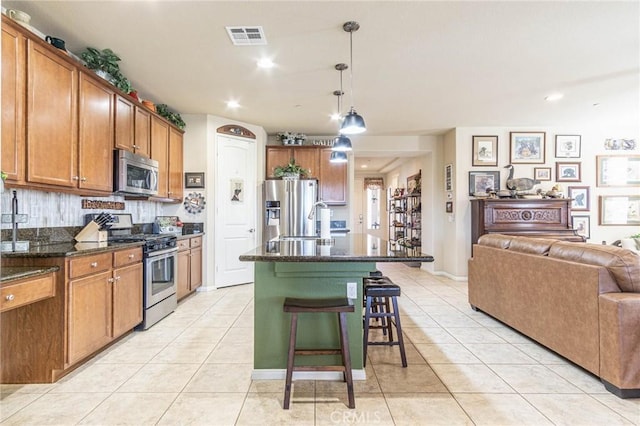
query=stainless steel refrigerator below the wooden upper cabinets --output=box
[262,179,318,242]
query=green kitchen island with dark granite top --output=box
[240,234,433,380]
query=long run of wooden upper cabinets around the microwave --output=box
[1,15,183,198]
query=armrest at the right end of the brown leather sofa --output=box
[598,293,640,395]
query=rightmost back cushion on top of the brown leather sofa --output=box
[549,241,640,293]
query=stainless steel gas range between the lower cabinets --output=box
[87,213,178,330]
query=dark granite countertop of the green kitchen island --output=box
[240,234,434,262]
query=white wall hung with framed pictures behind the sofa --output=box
[441,124,640,276]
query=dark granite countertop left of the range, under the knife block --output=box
[2,241,144,260]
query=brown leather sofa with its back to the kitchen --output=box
[469,234,640,398]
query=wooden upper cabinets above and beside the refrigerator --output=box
[265,145,347,205]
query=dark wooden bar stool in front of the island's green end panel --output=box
[283,297,356,410]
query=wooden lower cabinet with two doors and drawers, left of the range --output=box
[67,247,142,364]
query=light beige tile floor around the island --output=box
[0,264,640,426]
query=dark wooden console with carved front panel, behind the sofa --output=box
[471,198,585,248]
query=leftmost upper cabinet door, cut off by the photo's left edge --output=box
[0,25,27,182]
